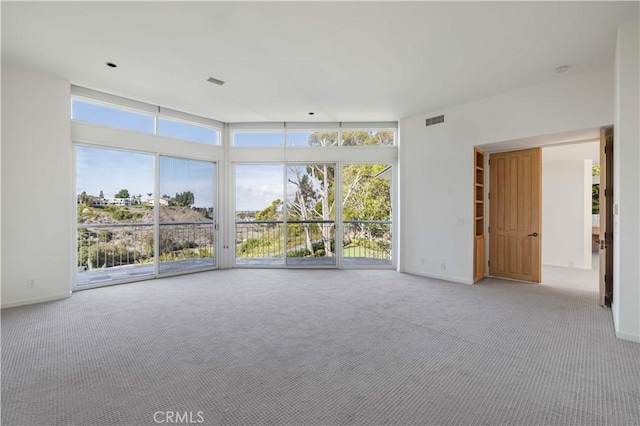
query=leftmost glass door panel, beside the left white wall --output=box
[76,146,155,287]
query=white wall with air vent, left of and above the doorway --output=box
[400,68,613,283]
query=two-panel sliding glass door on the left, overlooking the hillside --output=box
[76,145,217,289]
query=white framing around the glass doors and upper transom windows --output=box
[70,86,400,269]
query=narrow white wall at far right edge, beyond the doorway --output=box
[612,21,640,342]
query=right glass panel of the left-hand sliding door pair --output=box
[155,156,216,274]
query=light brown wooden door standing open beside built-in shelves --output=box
[489,148,542,283]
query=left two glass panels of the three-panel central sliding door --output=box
[235,164,337,267]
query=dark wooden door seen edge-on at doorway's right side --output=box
[599,127,613,306]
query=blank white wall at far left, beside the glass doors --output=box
[1,65,73,307]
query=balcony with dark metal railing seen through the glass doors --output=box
[77,220,392,287]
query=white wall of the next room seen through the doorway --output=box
[542,158,593,268]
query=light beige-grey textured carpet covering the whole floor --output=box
[2,270,640,426]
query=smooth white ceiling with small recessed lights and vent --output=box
[1,1,640,122]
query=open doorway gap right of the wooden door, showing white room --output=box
[542,140,600,292]
